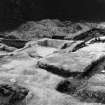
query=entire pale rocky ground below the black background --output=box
[0,20,105,105]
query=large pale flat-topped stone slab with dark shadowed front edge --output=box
[37,44,104,77]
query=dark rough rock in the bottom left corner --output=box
[0,84,29,105]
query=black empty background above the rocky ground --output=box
[0,0,105,31]
